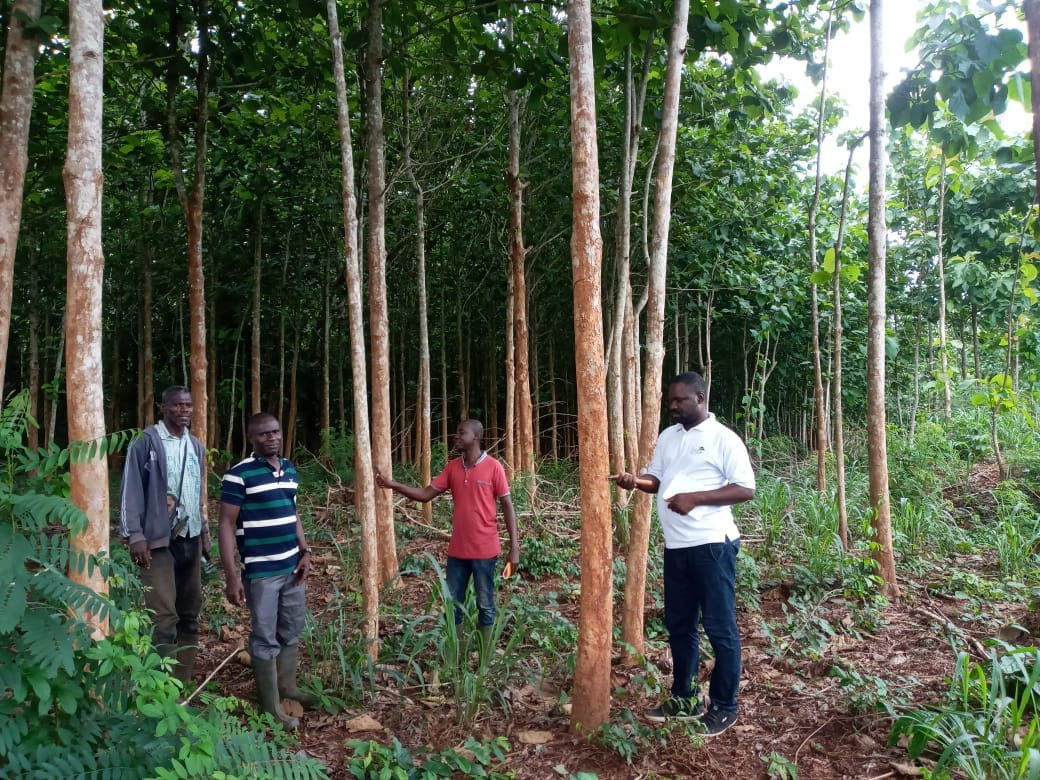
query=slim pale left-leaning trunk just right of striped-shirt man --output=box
[327,0,381,660]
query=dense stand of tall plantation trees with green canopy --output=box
[0,0,1040,740]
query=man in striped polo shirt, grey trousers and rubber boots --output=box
[219,413,318,729]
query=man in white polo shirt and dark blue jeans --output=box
[610,372,755,735]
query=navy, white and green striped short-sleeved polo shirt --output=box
[220,457,300,579]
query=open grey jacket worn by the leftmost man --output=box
[120,425,206,549]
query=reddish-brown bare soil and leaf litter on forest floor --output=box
[185,470,1037,780]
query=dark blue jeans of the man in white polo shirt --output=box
[665,540,740,712]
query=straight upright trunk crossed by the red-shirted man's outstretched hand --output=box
[366,0,397,586]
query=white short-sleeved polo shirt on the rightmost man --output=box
[646,413,755,549]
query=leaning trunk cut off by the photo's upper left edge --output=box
[0,0,40,398]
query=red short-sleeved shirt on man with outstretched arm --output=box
[431,452,510,561]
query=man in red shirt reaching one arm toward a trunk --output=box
[375,420,520,647]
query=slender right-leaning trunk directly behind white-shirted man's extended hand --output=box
[615,0,690,655]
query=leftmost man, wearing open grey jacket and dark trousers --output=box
[120,385,210,687]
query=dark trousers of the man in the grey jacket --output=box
[140,537,202,652]
